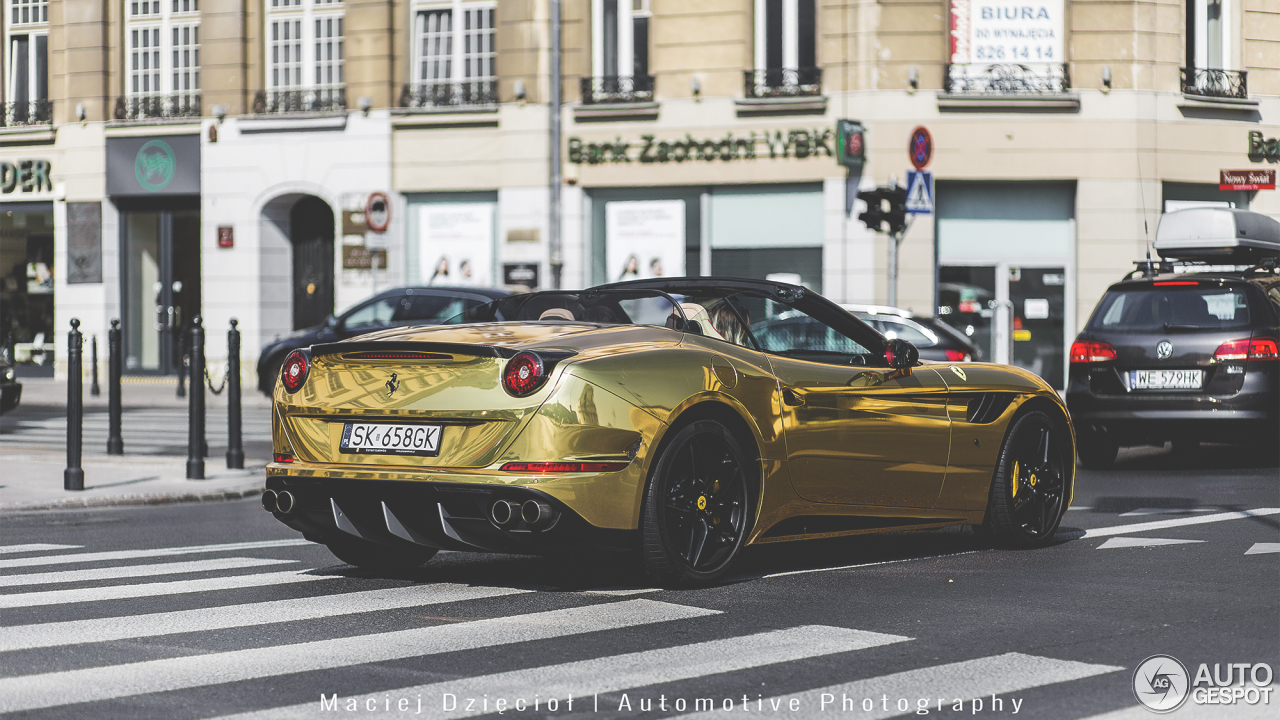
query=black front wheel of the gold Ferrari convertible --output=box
[984,411,1070,547]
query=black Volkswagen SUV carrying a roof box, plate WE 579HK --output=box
[1066,210,1280,466]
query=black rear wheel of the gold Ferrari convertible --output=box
[643,420,750,587]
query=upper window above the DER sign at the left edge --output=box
[0,0,52,126]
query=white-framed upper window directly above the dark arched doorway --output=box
[253,0,347,113]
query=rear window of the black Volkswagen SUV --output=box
[1089,283,1249,332]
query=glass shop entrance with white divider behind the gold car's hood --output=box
[938,263,1068,389]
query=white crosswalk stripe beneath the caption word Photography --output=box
[677,652,1124,720]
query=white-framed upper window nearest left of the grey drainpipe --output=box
[401,0,498,108]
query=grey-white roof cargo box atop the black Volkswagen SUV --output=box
[1156,208,1280,265]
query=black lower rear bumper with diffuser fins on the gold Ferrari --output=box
[266,475,637,553]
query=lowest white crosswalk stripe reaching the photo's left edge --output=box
[0,600,718,712]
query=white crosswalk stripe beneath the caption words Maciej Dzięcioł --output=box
[221,625,911,720]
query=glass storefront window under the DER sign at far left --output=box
[0,204,55,366]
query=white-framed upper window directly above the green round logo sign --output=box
[115,0,200,120]
